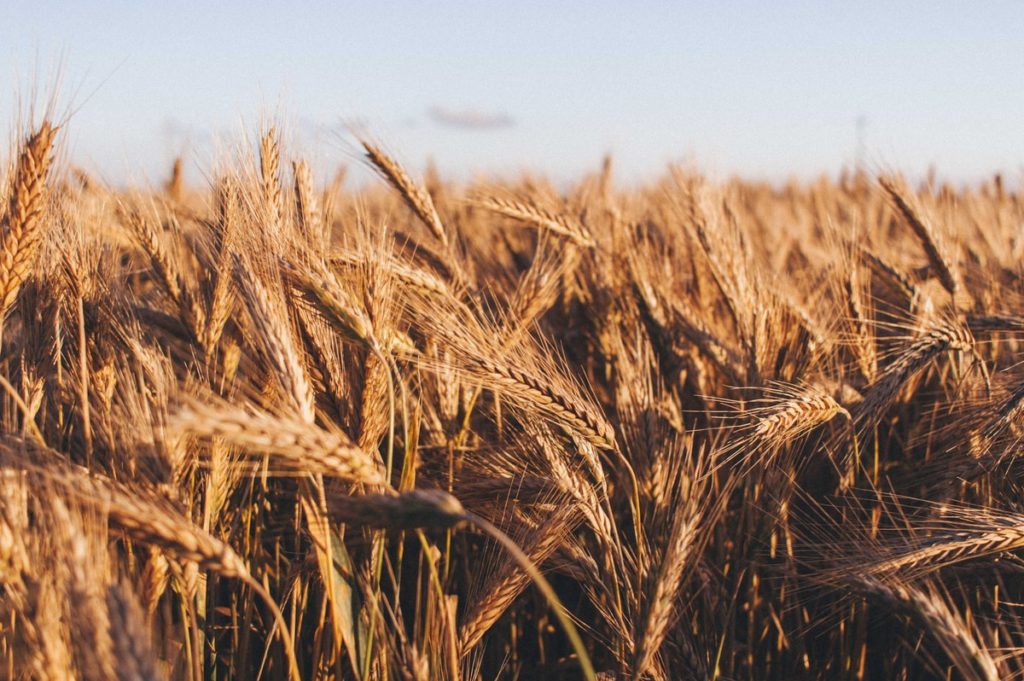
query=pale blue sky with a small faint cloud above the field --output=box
[0,0,1024,182]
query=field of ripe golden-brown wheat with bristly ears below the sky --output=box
[0,122,1024,681]
